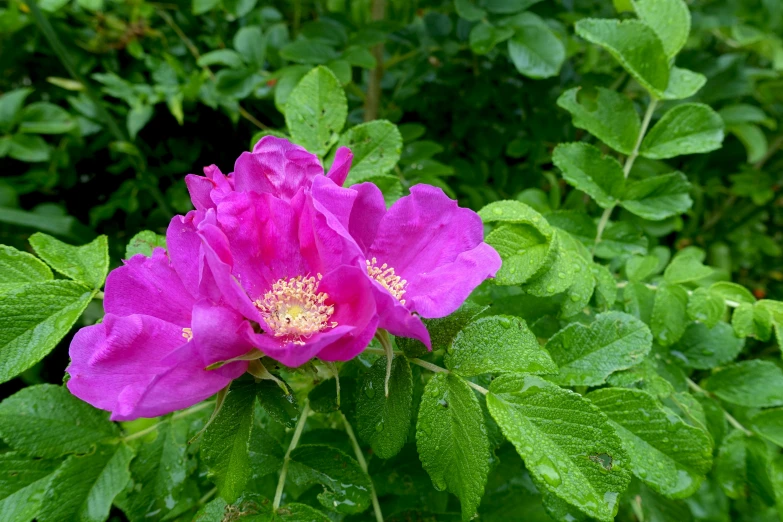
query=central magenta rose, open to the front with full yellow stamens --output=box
[197,187,378,366]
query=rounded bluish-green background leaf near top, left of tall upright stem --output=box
[508,13,565,79]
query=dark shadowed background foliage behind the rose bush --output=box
[0,0,783,520]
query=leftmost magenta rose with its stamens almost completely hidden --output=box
[66,244,253,420]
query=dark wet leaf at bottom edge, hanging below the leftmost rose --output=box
[117,419,189,522]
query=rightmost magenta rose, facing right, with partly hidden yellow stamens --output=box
[312,178,501,347]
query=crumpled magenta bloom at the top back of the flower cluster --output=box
[234,136,324,200]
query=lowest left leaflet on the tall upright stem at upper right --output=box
[552,143,625,208]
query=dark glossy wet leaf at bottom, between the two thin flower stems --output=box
[288,444,372,514]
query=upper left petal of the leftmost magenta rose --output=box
[103,248,195,327]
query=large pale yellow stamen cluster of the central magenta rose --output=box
[254,274,337,344]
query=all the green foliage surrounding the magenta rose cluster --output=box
[0,0,783,522]
